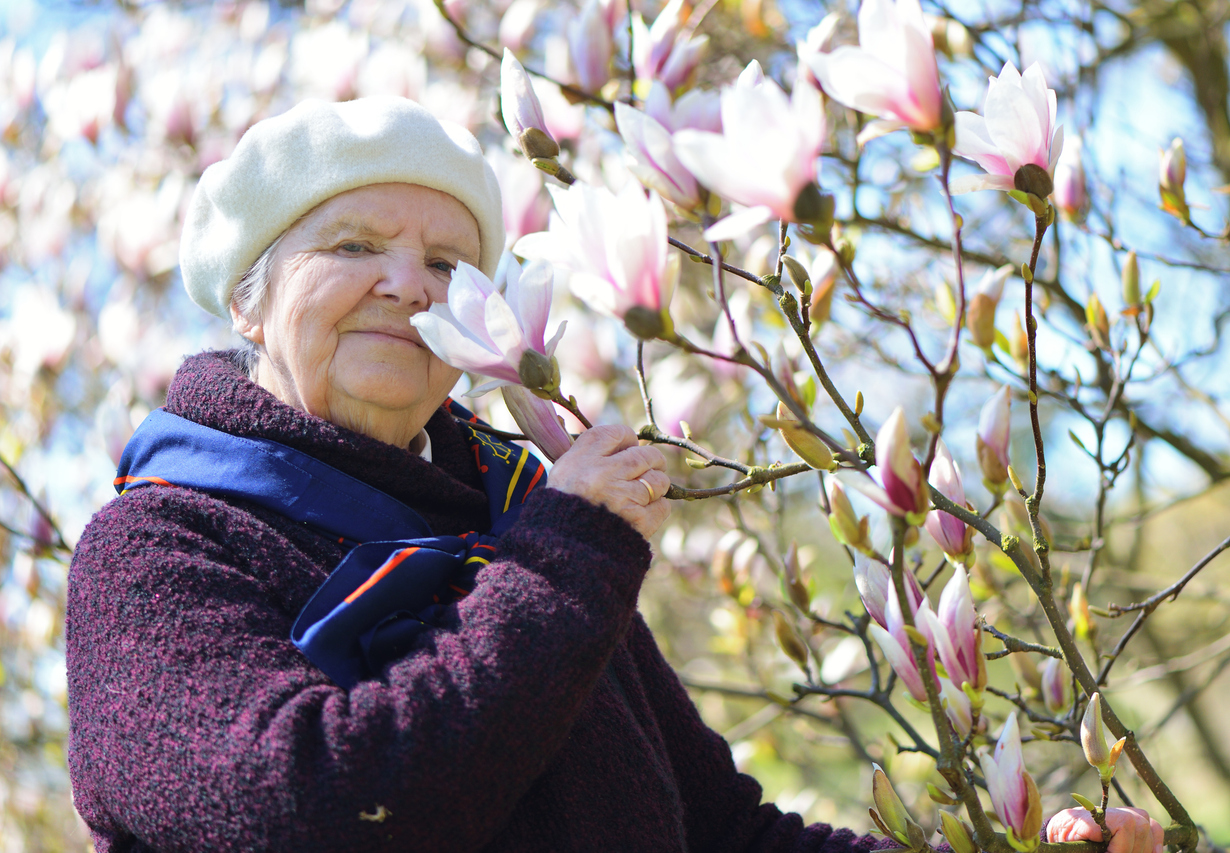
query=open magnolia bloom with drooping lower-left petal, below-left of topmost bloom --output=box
[674,60,824,240]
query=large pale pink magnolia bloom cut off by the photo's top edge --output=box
[808,0,943,144]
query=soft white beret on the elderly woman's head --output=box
[180,97,504,320]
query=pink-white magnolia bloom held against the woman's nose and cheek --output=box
[410,255,563,396]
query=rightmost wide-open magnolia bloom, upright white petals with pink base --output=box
[951,63,1064,198]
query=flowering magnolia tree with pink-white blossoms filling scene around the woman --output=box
[0,0,1230,853]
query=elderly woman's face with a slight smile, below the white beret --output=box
[236,183,480,449]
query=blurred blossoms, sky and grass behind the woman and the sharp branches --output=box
[0,0,1230,853]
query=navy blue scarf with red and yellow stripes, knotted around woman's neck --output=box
[114,400,546,688]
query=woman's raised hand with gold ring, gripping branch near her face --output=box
[551,426,670,539]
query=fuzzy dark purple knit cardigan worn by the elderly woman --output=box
[66,353,881,853]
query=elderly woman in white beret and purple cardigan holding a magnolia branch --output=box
[66,98,1156,853]
